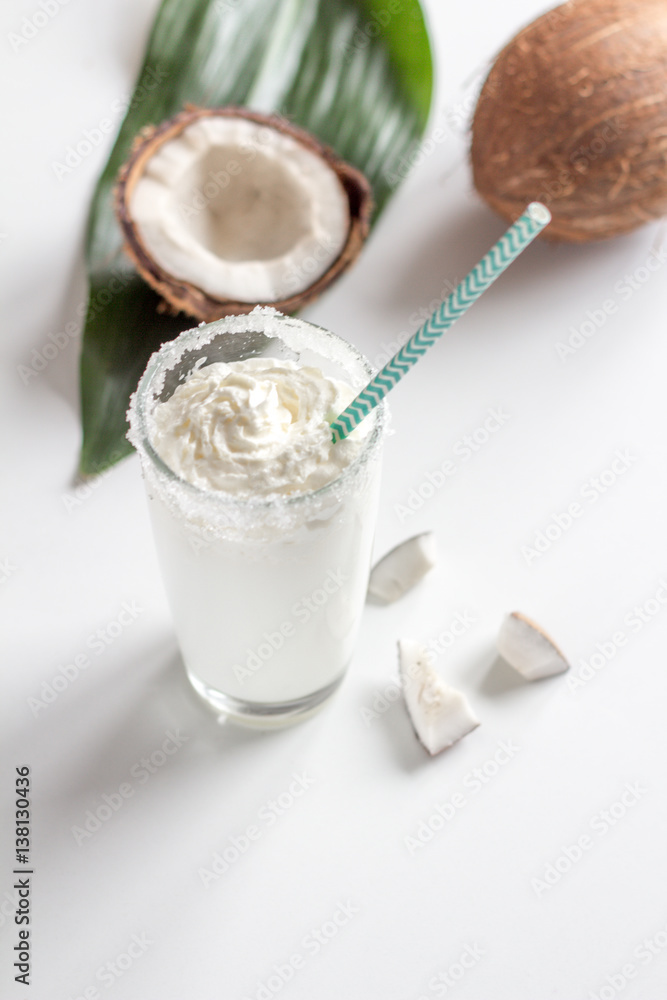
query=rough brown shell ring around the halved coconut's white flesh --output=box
[115,105,373,323]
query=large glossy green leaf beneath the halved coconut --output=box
[81,0,432,474]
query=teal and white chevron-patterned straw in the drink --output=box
[331,201,551,442]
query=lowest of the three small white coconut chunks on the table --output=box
[398,639,479,754]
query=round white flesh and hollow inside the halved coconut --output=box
[129,117,350,302]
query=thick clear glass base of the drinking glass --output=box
[186,668,345,729]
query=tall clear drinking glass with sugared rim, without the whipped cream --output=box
[129,309,385,726]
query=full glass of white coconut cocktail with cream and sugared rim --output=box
[129,308,384,725]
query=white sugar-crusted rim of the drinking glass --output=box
[129,307,387,510]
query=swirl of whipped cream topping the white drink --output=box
[151,358,363,497]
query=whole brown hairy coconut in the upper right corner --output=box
[471,0,667,243]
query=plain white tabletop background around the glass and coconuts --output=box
[0,0,667,1000]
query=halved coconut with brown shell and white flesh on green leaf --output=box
[116,107,372,322]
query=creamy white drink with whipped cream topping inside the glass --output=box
[150,358,379,704]
